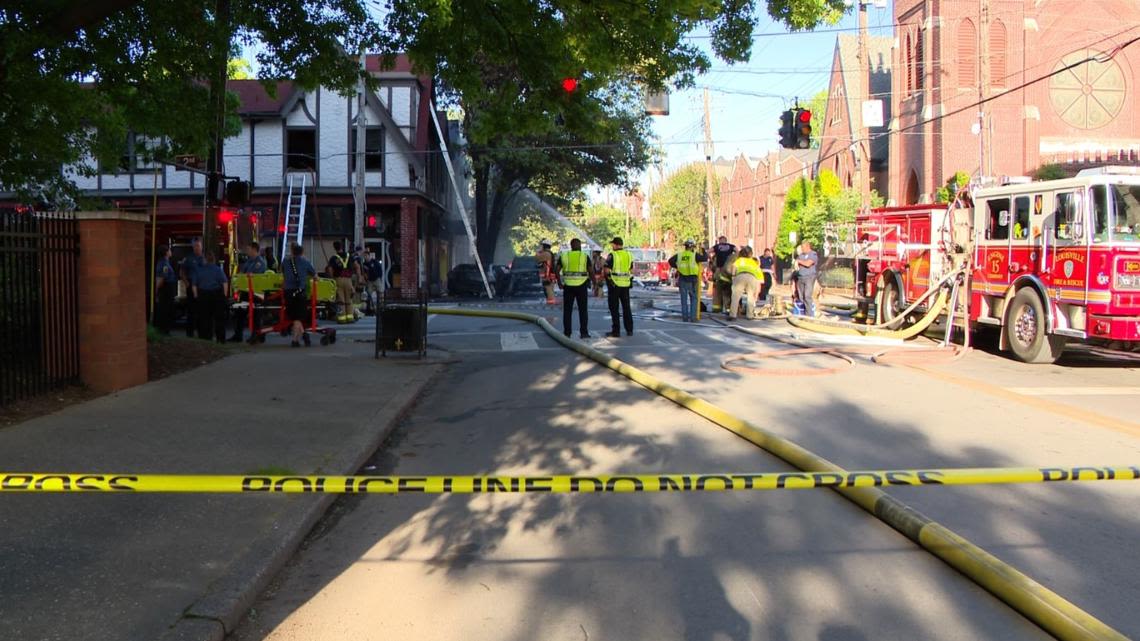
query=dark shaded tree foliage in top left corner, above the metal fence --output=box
[0,0,381,200]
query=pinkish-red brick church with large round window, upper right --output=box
[888,0,1140,204]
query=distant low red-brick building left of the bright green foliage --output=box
[716,149,819,251]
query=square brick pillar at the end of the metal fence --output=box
[75,211,147,392]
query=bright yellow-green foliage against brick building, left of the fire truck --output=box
[773,169,857,258]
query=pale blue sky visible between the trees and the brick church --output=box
[653,2,894,173]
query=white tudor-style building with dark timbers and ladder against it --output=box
[53,56,462,292]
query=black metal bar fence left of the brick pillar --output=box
[0,212,79,406]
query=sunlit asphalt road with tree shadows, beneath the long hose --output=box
[233,296,1140,641]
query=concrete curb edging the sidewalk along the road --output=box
[160,364,443,641]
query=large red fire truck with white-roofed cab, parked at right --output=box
[848,167,1140,363]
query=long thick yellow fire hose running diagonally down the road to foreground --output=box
[428,303,1127,641]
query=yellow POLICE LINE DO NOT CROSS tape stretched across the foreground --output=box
[0,465,1140,494]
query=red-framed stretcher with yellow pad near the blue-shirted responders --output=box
[230,271,336,344]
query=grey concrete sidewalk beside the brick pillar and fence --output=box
[0,340,441,641]
